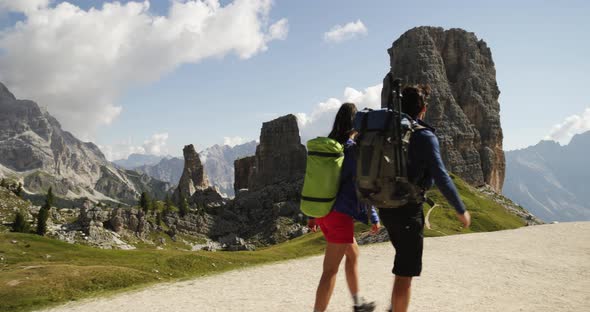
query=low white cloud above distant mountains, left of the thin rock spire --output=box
[98,133,168,161]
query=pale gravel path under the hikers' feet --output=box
[41,222,590,312]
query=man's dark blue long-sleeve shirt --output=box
[408,120,466,214]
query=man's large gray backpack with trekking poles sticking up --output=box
[355,74,426,208]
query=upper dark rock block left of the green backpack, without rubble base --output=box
[248,115,307,191]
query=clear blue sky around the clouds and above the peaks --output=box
[0,0,590,160]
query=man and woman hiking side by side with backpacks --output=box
[302,85,471,312]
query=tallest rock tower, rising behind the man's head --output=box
[382,27,506,192]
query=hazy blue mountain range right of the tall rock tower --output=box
[503,131,590,222]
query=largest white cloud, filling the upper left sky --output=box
[0,0,288,137]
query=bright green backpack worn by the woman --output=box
[301,137,344,218]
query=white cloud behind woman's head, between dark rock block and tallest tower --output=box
[295,84,382,142]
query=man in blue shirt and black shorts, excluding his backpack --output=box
[379,85,471,312]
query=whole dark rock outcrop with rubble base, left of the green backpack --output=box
[215,115,306,245]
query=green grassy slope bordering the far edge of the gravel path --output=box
[0,178,524,311]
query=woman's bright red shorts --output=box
[316,210,354,244]
